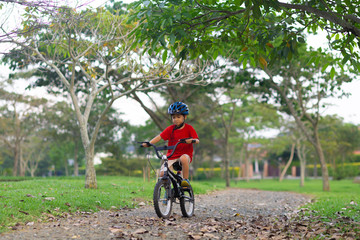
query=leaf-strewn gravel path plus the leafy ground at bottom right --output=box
[0,190,360,240]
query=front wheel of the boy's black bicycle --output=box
[153,180,172,218]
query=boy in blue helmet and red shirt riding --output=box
[143,102,200,187]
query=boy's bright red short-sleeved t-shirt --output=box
[160,124,199,162]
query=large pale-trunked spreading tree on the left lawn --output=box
[5,4,211,188]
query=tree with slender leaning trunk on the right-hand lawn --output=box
[250,46,351,191]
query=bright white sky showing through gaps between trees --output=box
[0,0,360,125]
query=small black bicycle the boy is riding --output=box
[138,138,195,218]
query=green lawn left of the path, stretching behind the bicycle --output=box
[0,177,225,232]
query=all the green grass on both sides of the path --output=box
[0,177,360,232]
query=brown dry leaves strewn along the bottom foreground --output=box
[105,214,360,239]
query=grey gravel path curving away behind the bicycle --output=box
[0,189,310,240]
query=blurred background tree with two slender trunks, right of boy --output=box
[208,70,278,187]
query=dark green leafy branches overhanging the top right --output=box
[131,0,360,71]
